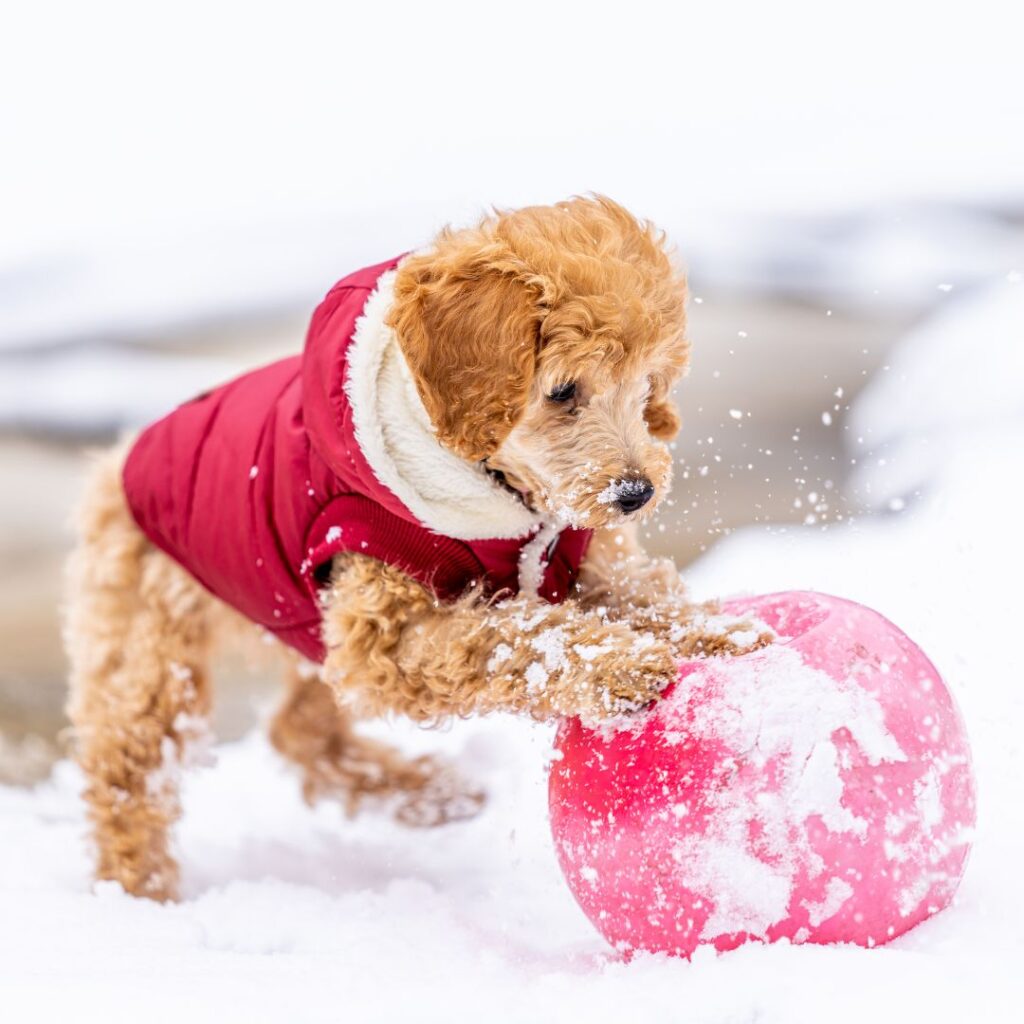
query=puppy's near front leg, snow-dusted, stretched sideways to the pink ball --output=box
[324,555,676,721]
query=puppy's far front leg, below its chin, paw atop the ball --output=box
[578,524,771,657]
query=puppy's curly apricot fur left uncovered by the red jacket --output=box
[67,198,769,899]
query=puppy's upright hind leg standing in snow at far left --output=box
[67,453,209,900]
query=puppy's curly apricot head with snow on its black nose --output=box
[389,197,688,526]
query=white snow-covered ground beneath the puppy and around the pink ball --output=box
[0,275,1024,1024]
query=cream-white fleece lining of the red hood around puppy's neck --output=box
[345,270,542,541]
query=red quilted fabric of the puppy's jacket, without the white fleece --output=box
[124,254,590,660]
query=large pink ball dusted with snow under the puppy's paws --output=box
[549,592,975,955]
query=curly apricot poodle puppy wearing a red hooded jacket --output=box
[65,197,770,900]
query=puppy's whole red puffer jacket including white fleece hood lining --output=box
[124,260,590,660]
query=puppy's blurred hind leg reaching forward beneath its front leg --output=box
[270,663,483,825]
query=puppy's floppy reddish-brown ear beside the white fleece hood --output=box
[388,245,543,461]
